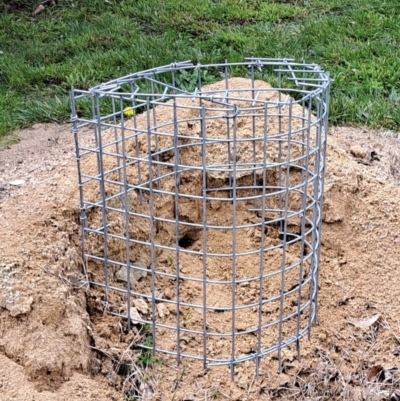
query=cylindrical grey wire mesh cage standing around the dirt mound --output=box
[71,58,330,375]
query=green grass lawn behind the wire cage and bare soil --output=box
[0,0,400,136]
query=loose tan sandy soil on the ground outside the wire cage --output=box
[0,83,400,401]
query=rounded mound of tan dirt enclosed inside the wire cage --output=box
[81,78,321,363]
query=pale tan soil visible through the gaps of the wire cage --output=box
[81,78,322,366]
